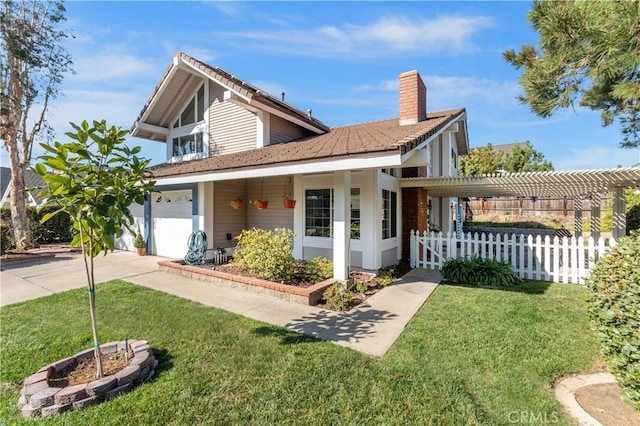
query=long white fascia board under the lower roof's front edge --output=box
[155,154,401,185]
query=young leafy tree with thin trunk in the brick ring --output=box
[34,120,155,377]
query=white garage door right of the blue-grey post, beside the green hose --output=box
[151,190,193,259]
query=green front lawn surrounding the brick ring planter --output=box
[0,281,598,425]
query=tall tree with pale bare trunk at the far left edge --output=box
[0,0,71,250]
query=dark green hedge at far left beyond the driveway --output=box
[0,207,73,244]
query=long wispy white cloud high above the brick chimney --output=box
[217,16,491,58]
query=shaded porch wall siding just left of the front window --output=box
[247,176,293,230]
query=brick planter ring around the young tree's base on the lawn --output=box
[18,340,158,417]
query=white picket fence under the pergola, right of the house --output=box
[410,231,616,284]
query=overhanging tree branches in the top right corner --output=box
[503,0,640,148]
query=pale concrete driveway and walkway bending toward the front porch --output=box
[0,251,441,357]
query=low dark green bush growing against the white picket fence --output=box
[440,256,522,287]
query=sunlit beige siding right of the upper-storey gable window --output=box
[209,82,256,156]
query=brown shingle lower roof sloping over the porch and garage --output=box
[150,108,465,178]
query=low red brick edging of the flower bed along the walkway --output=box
[158,261,335,305]
